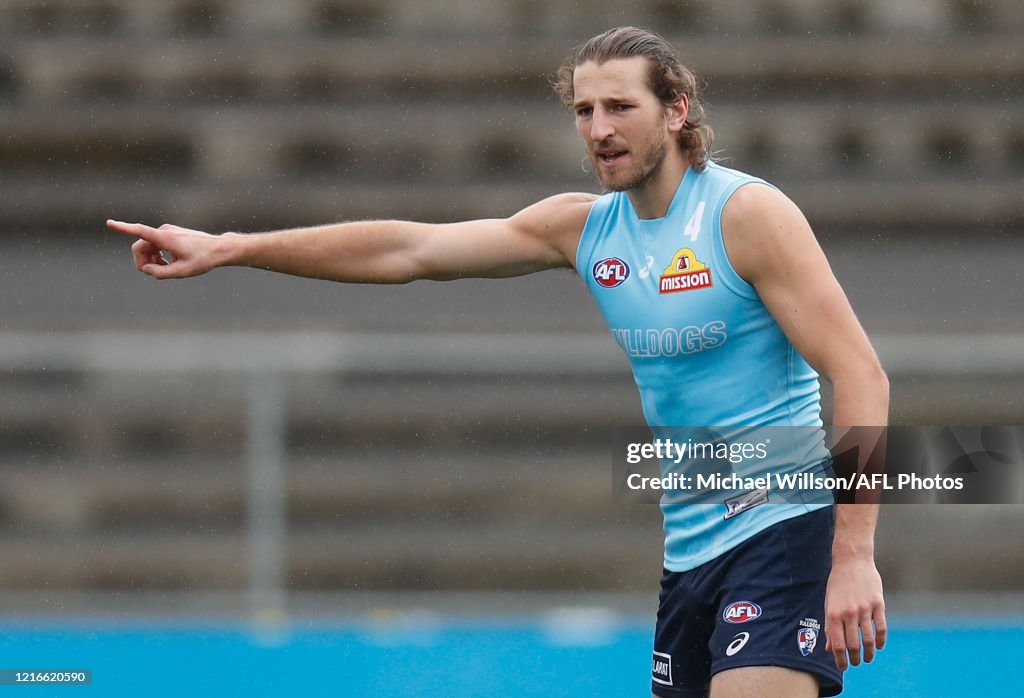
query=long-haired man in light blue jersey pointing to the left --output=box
[108,28,888,698]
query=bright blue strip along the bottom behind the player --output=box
[0,618,1024,698]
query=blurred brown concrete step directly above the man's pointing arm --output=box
[0,172,1024,234]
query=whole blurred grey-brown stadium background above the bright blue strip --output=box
[0,0,1024,695]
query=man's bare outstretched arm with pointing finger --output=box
[106,193,594,283]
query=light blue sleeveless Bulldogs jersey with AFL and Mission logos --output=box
[577,163,828,572]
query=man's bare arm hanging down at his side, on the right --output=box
[722,184,889,670]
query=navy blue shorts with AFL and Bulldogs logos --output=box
[651,507,843,698]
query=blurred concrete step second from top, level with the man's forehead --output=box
[0,33,1024,105]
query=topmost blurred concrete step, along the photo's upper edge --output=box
[0,0,1020,39]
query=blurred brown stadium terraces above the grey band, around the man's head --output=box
[0,0,1024,232]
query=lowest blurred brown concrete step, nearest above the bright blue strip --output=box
[0,505,1024,593]
